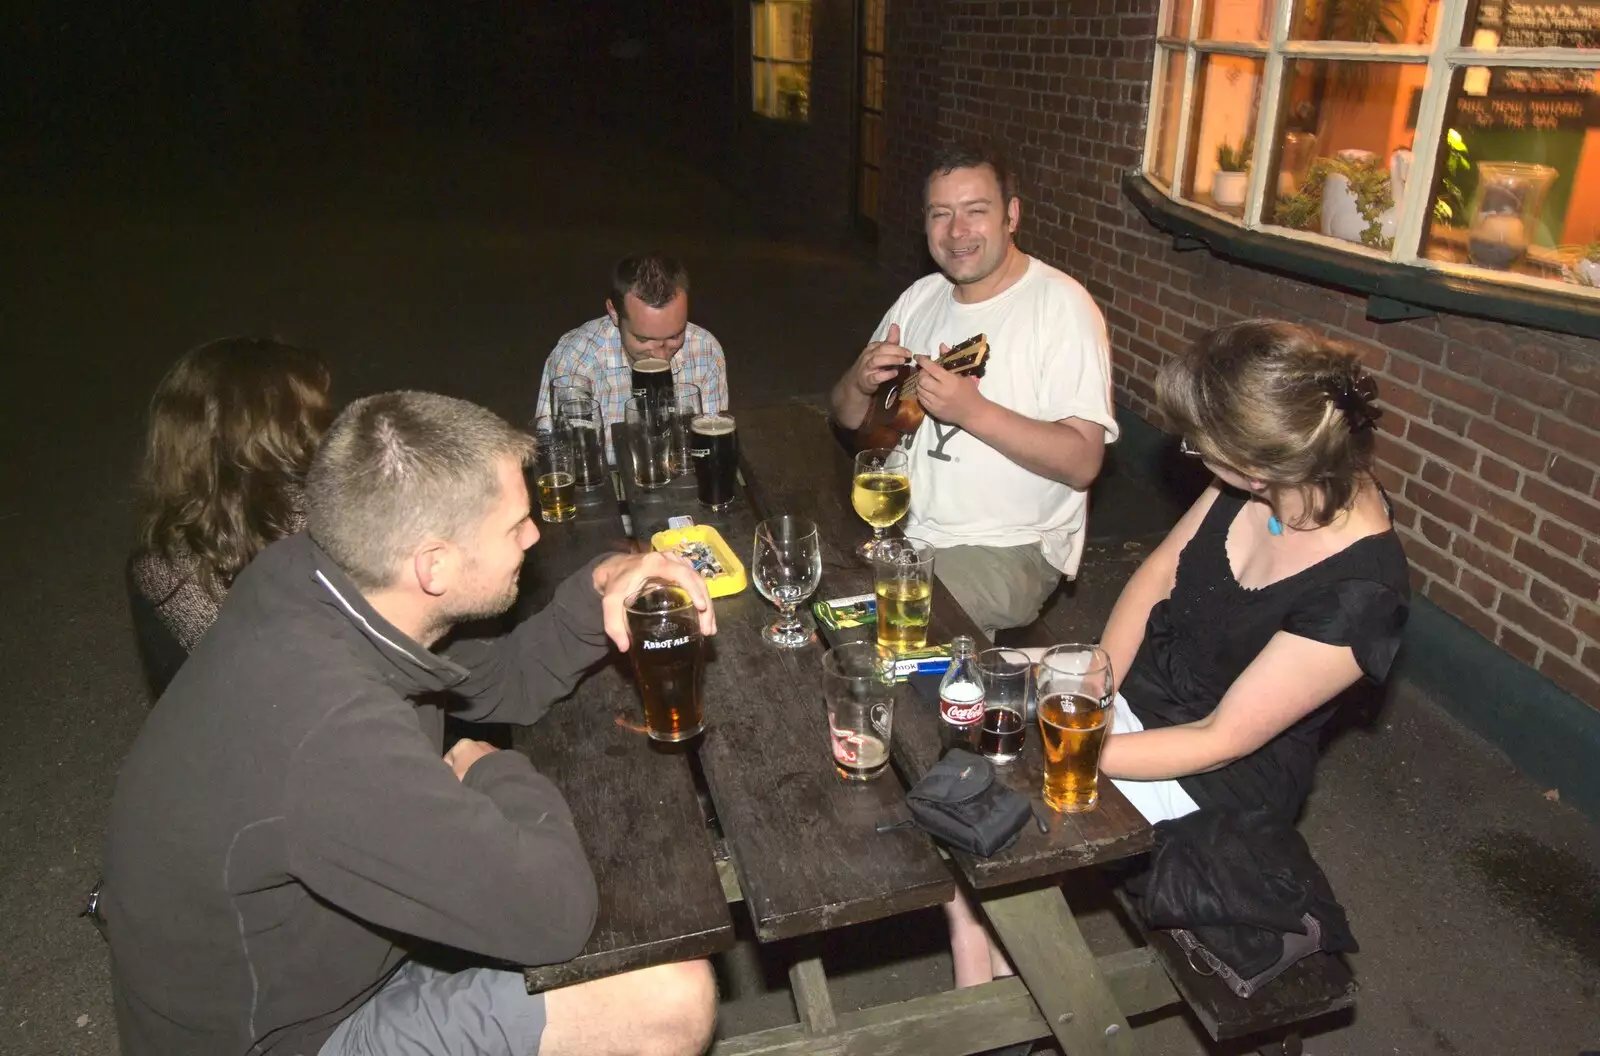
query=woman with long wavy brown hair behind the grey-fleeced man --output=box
[128,338,331,696]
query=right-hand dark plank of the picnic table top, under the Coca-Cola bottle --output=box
[739,403,1152,888]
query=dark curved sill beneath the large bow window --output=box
[1122,173,1600,338]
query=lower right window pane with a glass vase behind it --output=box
[1424,67,1600,285]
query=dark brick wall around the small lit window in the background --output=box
[726,0,864,243]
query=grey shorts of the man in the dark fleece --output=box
[318,960,544,1056]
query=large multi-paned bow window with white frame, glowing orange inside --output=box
[1144,0,1600,296]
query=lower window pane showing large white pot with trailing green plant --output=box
[1262,59,1427,250]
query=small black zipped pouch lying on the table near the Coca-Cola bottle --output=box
[906,749,1032,858]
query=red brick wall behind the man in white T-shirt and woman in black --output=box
[880,0,1600,707]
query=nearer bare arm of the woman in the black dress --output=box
[1101,630,1362,781]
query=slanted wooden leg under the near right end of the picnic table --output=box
[982,886,1133,1056]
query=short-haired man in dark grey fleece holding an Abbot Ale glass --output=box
[102,392,715,1056]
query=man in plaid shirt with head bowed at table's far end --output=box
[534,254,728,461]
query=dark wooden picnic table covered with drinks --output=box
[518,403,1174,1056]
